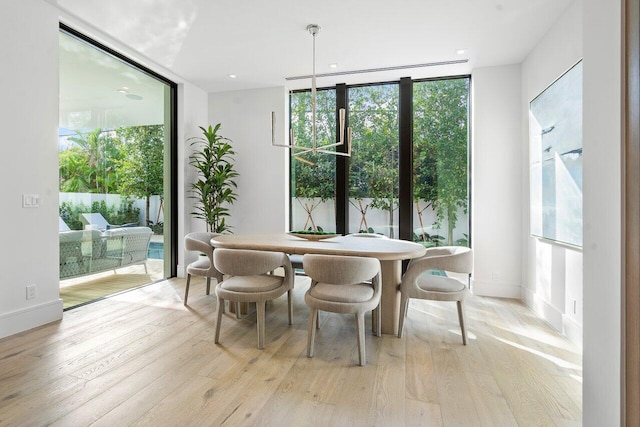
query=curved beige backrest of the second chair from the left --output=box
[213,248,293,280]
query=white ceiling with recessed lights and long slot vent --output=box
[48,0,571,92]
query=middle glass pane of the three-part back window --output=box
[349,84,399,238]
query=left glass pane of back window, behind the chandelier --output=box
[291,90,336,232]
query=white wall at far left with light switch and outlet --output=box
[0,1,62,338]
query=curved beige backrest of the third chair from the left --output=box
[302,254,380,285]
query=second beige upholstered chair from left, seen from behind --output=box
[213,248,294,349]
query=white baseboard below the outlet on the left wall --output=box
[0,298,63,338]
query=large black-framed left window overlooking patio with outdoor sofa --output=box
[58,26,176,308]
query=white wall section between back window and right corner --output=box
[471,65,522,298]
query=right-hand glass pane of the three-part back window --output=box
[413,78,469,247]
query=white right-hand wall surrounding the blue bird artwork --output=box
[520,0,584,345]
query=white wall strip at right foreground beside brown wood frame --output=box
[583,0,624,427]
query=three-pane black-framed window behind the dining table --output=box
[291,76,470,246]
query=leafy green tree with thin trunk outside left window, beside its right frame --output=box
[116,125,164,225]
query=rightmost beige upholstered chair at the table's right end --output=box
[398,246,473,345]
